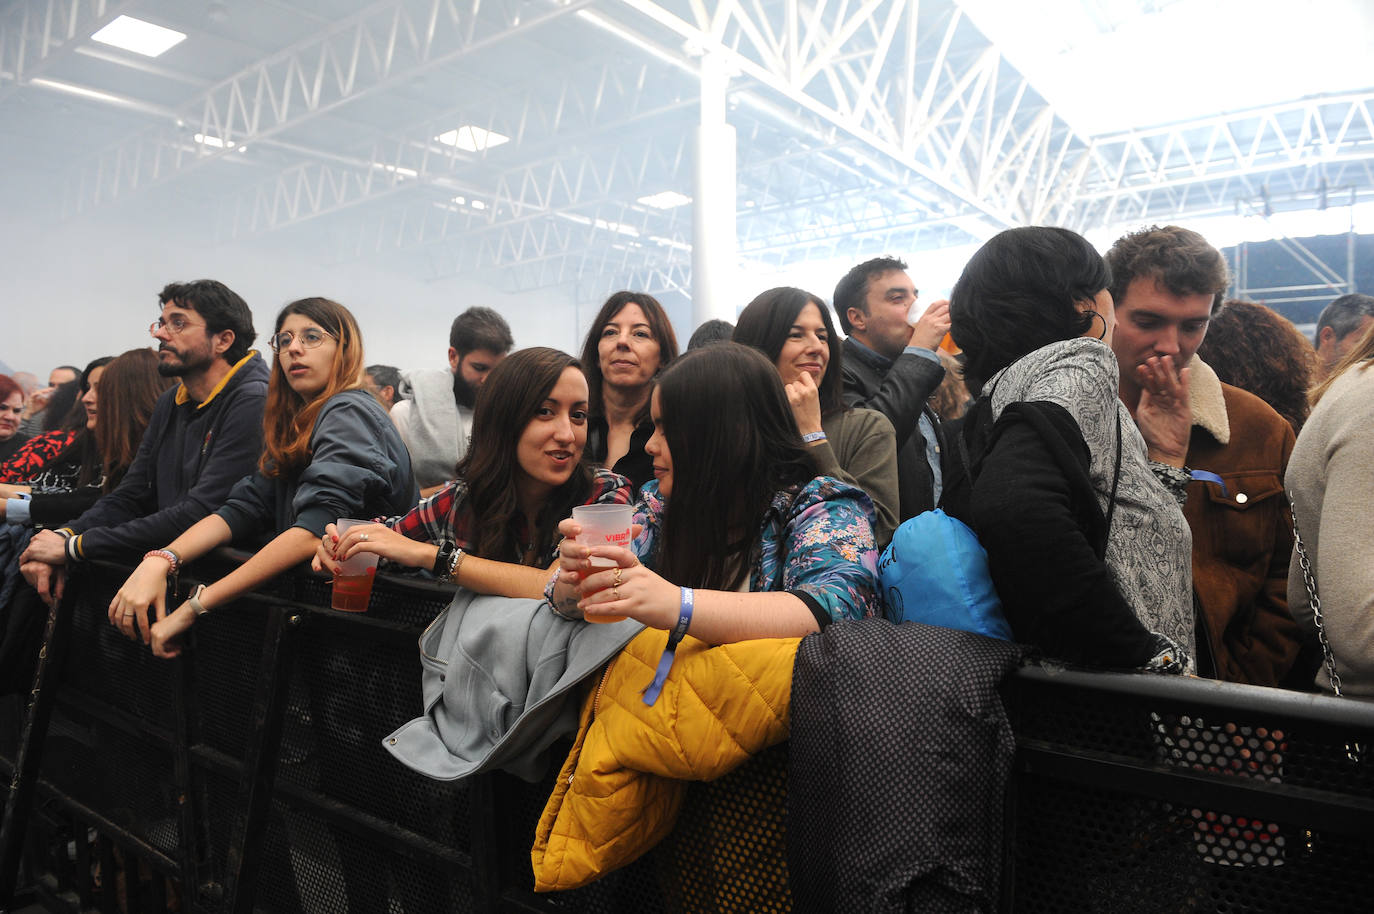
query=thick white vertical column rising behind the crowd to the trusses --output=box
[691,51,743,327]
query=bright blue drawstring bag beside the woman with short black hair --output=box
[878,509,1015,640]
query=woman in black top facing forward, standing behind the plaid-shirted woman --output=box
[583,291,677,488]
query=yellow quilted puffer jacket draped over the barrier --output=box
[530,629,801,892]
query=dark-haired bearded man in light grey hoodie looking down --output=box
[392,308,515,498]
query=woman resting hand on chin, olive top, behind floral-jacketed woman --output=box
[734,287,899,548]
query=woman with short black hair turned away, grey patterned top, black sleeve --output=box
[947,227,1193,672]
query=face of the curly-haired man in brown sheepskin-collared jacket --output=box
[1112,276,1212,394]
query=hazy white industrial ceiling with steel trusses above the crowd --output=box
[0,0,1374,302]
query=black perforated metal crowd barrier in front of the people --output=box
[0,555,1374,914]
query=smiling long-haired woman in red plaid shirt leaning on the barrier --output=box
[315,348,633,598]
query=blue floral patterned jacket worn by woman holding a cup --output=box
[633,476,882,627]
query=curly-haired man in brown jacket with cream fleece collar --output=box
[1106,225,1300,686]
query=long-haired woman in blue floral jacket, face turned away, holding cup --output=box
[548,342,878,643]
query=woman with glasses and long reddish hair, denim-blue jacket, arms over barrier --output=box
[110,298,419,657]
